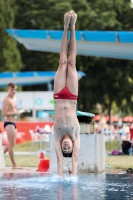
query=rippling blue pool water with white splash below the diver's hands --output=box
[0,173,133,200]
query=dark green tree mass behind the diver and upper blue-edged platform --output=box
[12,0,133,114]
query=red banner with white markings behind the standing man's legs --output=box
[0,122,54,145]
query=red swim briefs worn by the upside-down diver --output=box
[54,87,78,100]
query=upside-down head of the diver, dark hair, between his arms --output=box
[61,135,73,157]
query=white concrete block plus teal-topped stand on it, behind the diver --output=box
[50,111,105,173]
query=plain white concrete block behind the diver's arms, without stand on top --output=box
[50,134,105,173]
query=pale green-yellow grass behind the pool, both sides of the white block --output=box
[5,141,133,169]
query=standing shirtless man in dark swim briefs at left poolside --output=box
[2,83,26,169]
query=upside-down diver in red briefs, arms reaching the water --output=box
[54,11,80,176]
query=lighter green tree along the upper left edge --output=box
[0,0,22,72]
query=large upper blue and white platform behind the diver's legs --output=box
[6,29,133,60]
